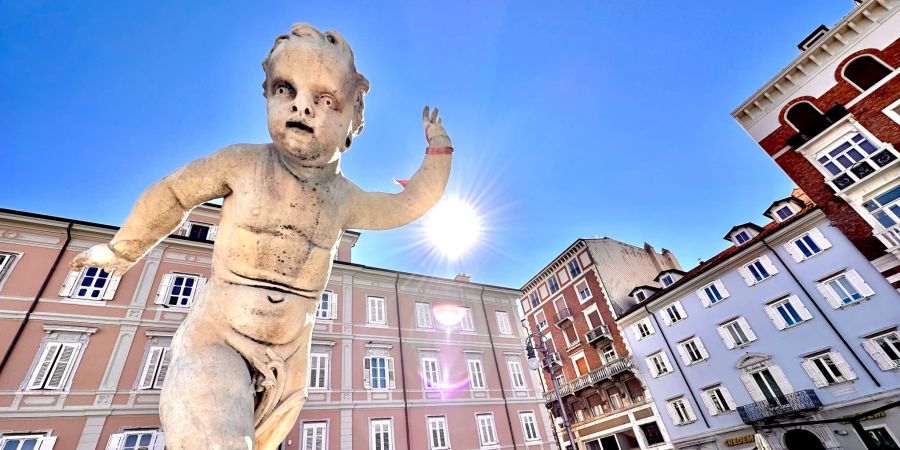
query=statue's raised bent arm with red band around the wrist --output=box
[344,106,453,230]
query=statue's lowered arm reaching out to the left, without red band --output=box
[72,147,240,275]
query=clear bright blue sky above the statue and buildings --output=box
[0,0,854,287]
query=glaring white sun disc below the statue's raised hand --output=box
[425,198,481,259]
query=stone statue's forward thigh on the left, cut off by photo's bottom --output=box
[160,323,254,450]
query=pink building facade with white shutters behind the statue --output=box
[0,205,556,450]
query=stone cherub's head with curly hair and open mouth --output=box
[262,24,369,166]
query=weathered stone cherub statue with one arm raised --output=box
[72,24,453,450]
